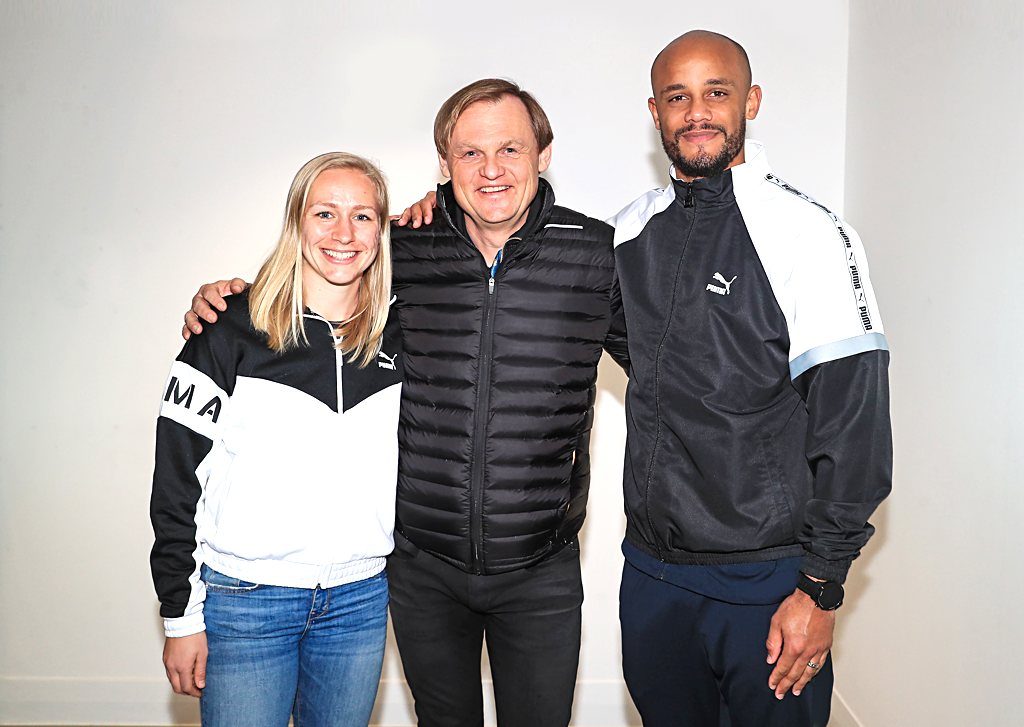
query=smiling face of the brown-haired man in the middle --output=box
[438,96,551,248]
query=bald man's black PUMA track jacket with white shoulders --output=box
[614,141,892,581]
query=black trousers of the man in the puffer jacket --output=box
[387,534,583,727]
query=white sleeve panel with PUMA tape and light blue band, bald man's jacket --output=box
[737,176,888,379]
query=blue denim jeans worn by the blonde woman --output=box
[200,565,388,727]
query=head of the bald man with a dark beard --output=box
[647,31,761,181]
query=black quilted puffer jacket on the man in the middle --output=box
[392,179,626,573]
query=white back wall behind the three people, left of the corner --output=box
[0,0,847,725]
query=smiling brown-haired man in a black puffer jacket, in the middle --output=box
[388,79,626,727]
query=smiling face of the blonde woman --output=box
[301,169,382,314]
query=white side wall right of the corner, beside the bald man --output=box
[837,0,1024,727]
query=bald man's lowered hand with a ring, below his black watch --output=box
[765,590,836,699]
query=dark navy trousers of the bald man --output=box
[618,562,833,727]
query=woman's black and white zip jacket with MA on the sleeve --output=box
[151,293,402,636]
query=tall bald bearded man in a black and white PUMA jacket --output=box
[614,31,892,727]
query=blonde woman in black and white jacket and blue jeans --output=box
[151,153,402,727]
